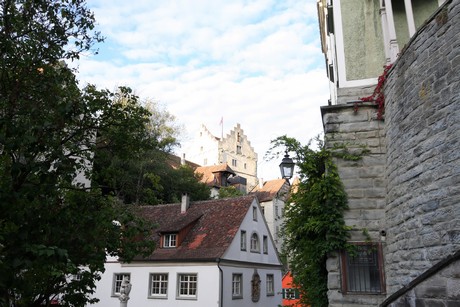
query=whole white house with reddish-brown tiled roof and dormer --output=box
[87,196,282,307]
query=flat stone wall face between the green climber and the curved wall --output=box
[321,104,386,307]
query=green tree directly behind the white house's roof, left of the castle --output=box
[95,99,210,205]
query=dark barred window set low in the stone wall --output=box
[342,243,385,293]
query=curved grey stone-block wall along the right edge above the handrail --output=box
[385,0,460,298]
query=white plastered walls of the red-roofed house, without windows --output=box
[86,198,282,307]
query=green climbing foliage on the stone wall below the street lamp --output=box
[270,136,349,307]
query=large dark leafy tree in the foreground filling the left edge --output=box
[0,0,152,306]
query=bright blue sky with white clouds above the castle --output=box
[77,0,329,180]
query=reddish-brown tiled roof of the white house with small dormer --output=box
[137,196,257,261]
